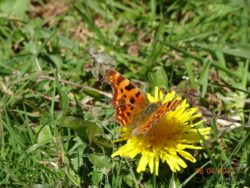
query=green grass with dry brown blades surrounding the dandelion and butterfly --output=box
[0,0,250,187]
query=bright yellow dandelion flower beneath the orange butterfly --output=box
[112,87,210,175]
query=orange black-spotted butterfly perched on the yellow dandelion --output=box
[105,70,181,135]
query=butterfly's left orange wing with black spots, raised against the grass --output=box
[105,70,149,126]
